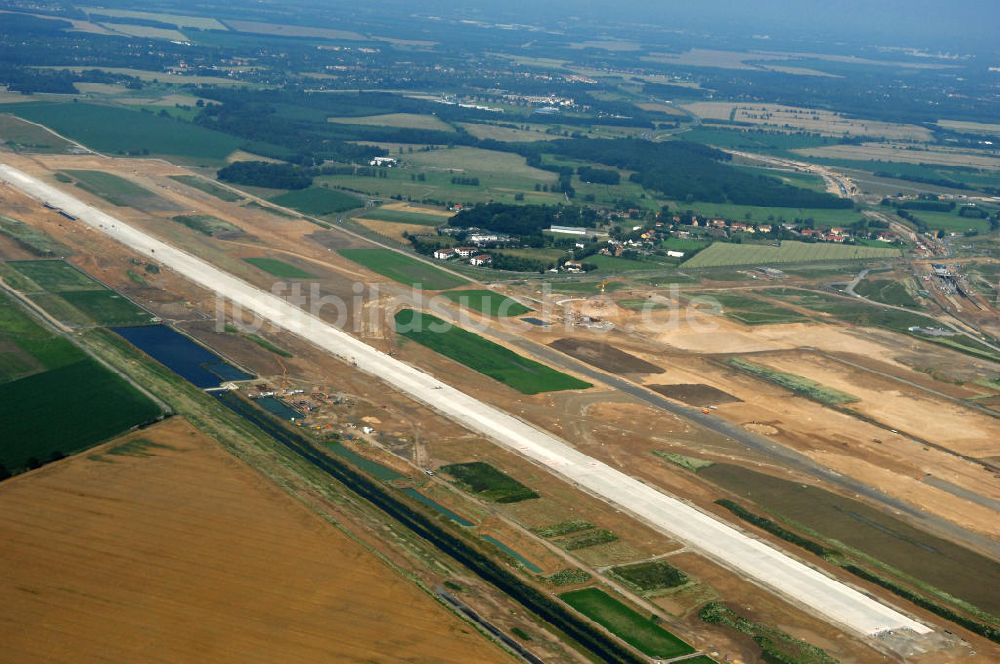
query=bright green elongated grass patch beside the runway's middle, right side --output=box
[396,309,591,394]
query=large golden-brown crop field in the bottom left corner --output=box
[0,418,510,662]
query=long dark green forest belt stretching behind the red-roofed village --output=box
[186,89,853,208]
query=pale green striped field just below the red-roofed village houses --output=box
[683,240,901,269]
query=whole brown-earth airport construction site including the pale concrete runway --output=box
[0,149,1000,662]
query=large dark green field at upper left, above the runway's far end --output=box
[0,103,240,165]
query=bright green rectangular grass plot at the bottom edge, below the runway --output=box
[559,588,694,659]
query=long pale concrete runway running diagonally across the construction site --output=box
[0,164,932,635]
